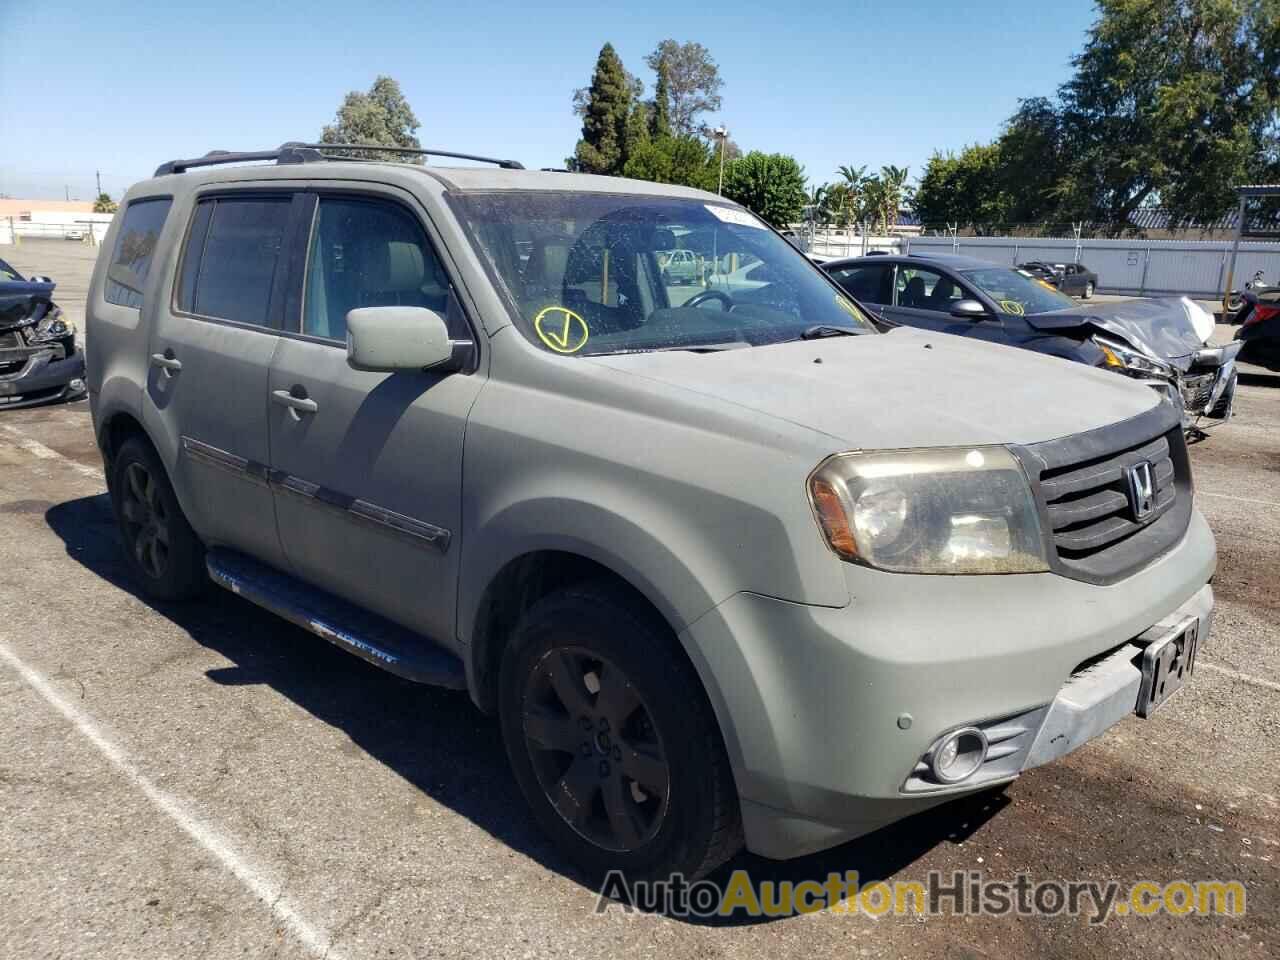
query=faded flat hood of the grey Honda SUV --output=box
[584,328,1160,449]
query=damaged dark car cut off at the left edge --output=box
[0,260,84,410]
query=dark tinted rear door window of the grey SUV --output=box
[185,197,292,326]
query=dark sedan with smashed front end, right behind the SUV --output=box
[822,253,1240,431]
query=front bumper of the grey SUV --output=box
[684,512,1216,859]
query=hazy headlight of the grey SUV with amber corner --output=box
[809,447,1048,573]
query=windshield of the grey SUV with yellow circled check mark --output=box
[453,192,874,356]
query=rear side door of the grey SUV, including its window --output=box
[146,186,298,566]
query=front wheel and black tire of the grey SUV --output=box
[498,584,742,882]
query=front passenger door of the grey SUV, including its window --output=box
[268,193,483,641]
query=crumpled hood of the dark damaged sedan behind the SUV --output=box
[1025,297,1213,370]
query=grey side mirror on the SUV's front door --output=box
[347,307,453,372]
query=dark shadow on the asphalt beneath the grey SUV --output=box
[45,493,1009,925]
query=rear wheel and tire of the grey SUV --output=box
[109,436,209,600]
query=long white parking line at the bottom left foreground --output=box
[0,640,339,960]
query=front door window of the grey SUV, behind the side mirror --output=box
[302,197,455,340]
